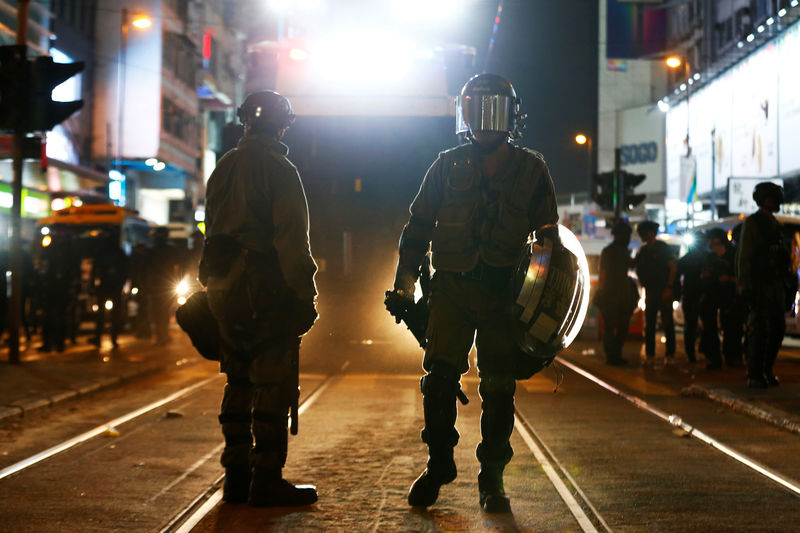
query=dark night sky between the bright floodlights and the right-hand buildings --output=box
[478,0,598,194]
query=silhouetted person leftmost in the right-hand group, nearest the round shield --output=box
[597,221,639,366]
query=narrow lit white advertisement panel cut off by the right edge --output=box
[778,19,800,174]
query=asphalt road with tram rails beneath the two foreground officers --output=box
[0,337,800,532]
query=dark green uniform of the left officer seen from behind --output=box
[206,133,317,470]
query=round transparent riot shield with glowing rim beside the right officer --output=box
[511,224,590,360]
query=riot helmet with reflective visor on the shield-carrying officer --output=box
[456,74,525,140]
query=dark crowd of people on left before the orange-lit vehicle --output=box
[0,227,202,352]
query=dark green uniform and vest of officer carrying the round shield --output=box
[395,145,558,498]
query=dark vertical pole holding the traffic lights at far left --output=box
[3,0,30,365]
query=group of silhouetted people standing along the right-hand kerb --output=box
[595,183,797,388]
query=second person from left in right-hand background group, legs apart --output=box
[635,220,677,363]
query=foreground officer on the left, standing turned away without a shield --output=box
[200,91,317,507]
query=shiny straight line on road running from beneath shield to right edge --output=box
[556,357,800,496]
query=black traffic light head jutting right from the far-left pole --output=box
[27,56,84,131]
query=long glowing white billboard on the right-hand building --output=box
[666,23,800,201]
